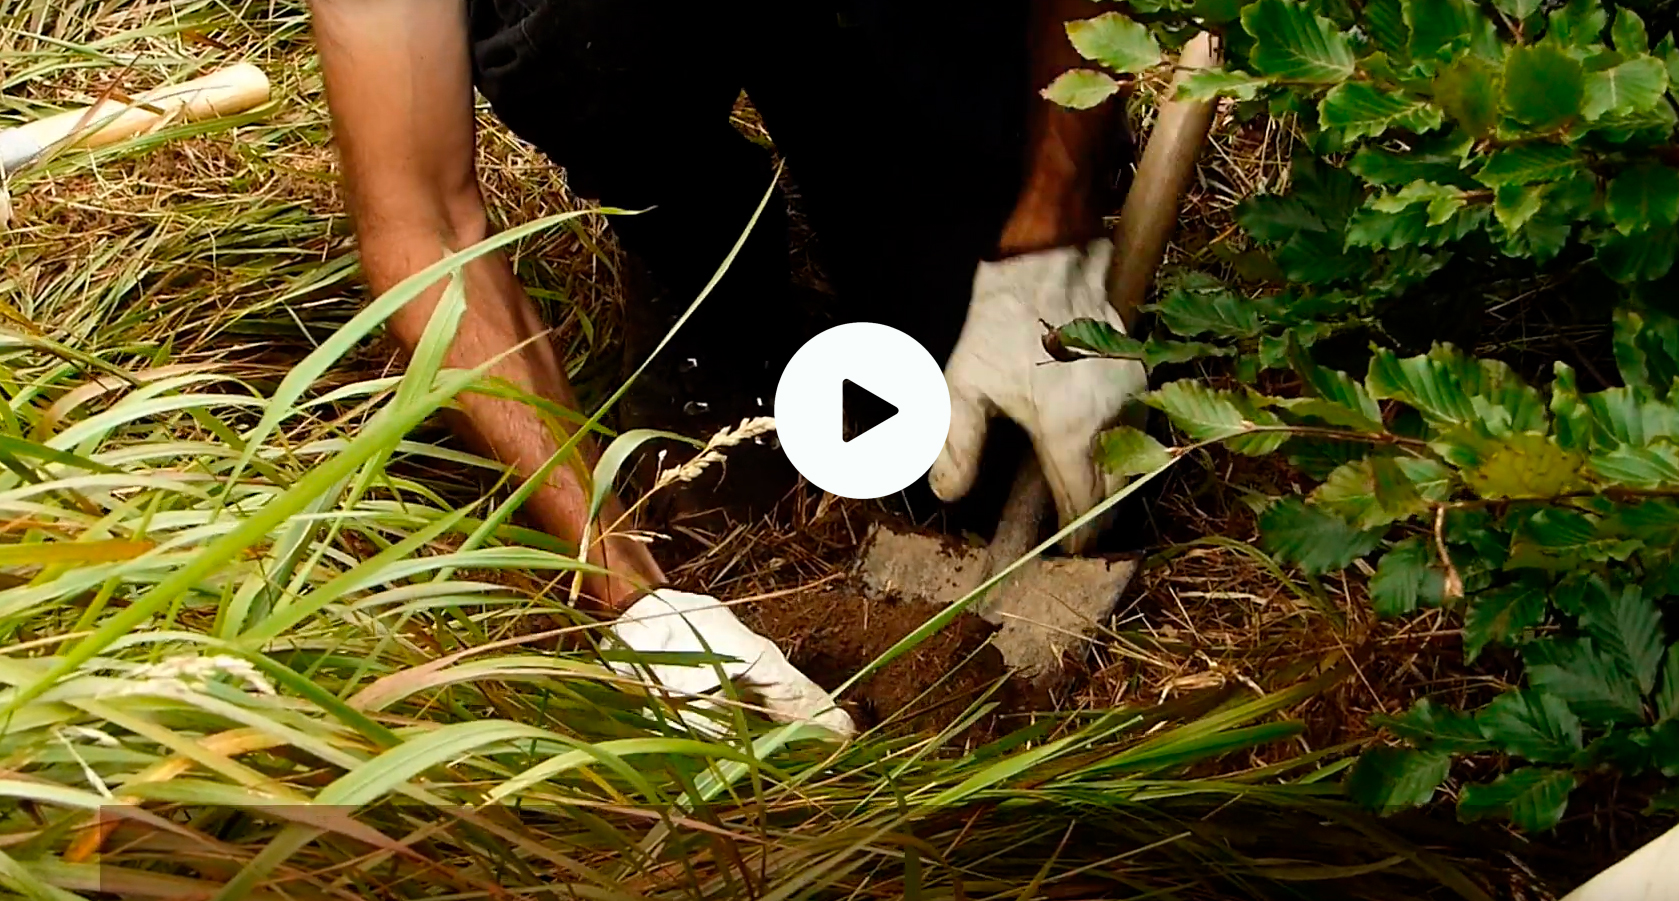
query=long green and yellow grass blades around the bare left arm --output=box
[0,0,1504,901]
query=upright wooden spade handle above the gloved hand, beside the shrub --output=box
[1108,32,1219,329]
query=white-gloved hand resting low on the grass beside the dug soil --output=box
[609,589,856,738]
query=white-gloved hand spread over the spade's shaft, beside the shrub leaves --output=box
[928,238,1148,554]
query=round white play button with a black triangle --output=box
[776,322,950,500]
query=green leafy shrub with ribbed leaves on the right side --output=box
[1044,0,1679,831]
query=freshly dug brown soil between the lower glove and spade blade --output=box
[740,591,1033,747]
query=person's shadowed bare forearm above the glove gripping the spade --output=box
[999,0,1123,257]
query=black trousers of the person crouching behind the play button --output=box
[468,0,1043,371]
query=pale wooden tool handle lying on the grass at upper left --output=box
[0,62,269,171]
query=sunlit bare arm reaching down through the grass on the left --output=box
[311,0,663,609]
